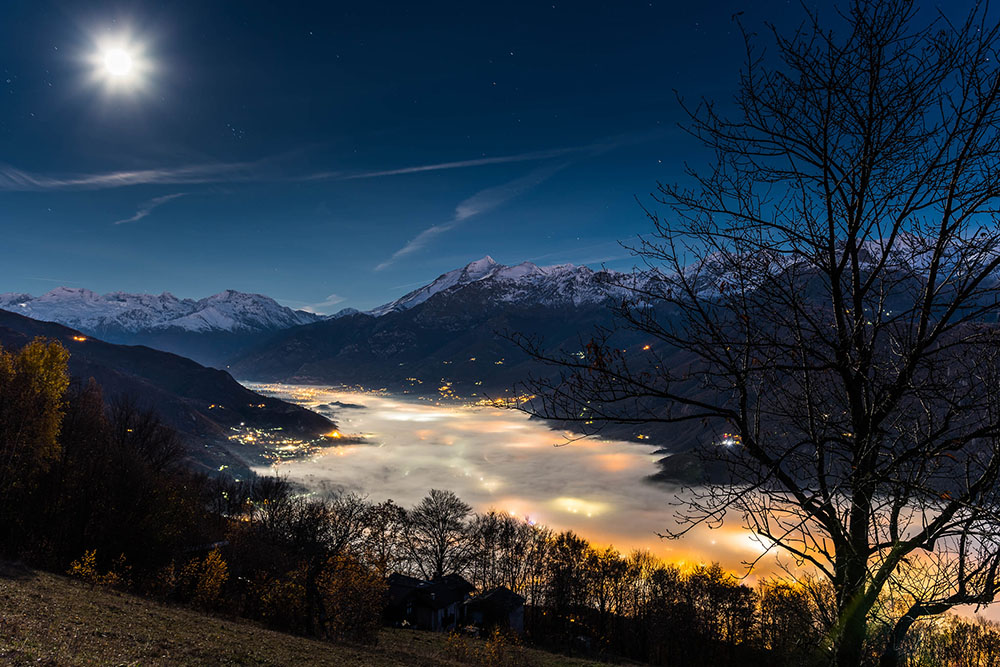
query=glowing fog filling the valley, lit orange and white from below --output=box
[247,383,773,571]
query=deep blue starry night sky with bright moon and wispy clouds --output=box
[0,0,968,312]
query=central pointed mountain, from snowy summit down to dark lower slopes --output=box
[230,257,652,398]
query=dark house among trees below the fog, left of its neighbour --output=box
[386,573,475,631]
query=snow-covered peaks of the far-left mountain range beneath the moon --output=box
[0,287,321,335]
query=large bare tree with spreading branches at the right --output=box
[519,0,1000,666]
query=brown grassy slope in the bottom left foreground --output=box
[0,563,595,667]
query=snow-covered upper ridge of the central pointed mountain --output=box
[367,255,649,317]
